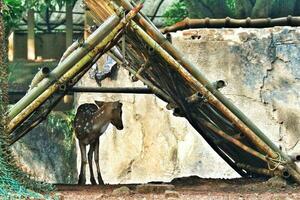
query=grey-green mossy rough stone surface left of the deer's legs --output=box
[12,119,77,184]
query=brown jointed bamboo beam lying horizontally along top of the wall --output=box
[161,16,300,34]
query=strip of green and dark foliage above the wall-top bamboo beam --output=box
[165,0,300,25]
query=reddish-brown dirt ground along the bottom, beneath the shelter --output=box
[57,178,300,200]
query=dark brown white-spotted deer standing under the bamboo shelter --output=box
[74,101,123,185]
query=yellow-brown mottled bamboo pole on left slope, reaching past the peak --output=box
[8,5,142,132]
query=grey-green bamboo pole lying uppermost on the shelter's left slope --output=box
[8,15,120,120]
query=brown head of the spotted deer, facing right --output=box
[95,101,124,130]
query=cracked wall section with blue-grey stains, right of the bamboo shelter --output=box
[173,27,300,153]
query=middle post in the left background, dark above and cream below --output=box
[27,9,35,60]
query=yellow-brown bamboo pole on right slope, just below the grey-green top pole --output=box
[131,21,300,183]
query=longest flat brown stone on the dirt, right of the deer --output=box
[136,184,175,193]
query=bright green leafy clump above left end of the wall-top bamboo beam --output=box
[164,1,188,26]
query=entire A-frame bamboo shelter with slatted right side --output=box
[8,0,300,183]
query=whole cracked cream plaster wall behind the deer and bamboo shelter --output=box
[78,27,300,183]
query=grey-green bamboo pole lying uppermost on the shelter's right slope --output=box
[110,0,291,162]
